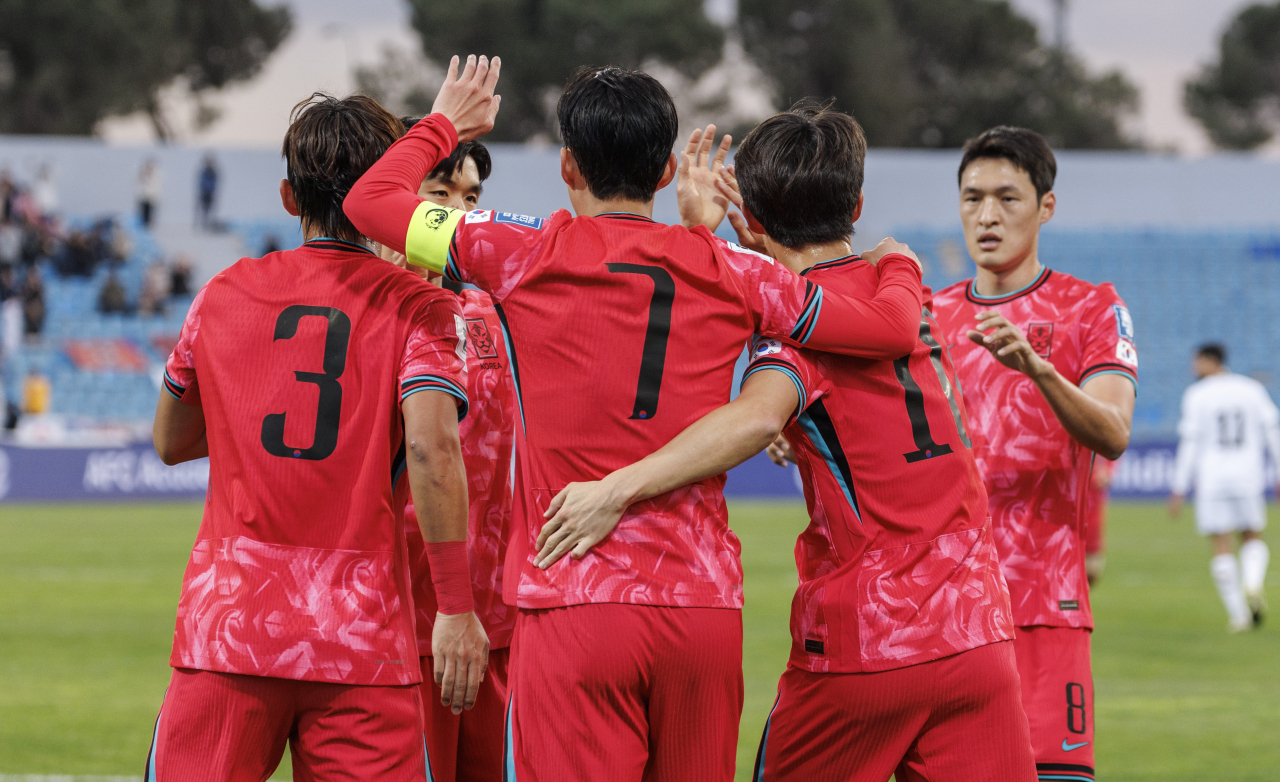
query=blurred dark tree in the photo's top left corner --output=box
[0,0,291,138]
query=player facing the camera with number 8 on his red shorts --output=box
[933,127,1138,781]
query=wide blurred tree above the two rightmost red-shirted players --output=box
[739,0,1138,148]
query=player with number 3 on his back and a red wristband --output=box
[146,84,492,781]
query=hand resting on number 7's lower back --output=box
[534,481,627,570]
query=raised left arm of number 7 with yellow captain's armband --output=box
[342,55,502,263]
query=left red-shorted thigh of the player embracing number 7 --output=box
[753,663,933,782]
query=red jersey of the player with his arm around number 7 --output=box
[746,257,1014,673]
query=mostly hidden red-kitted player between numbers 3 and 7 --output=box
[383,136,516,782]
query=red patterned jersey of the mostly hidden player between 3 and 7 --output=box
[404,289,518,647]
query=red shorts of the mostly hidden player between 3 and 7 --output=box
[422,649,511,782]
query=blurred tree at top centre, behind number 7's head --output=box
[408,0,724,141]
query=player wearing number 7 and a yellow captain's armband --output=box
[346,59,920,782]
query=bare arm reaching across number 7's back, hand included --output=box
[535,360,804,568]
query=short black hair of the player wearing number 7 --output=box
[556,65,680,201]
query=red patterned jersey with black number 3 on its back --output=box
[165,239,467,685]
